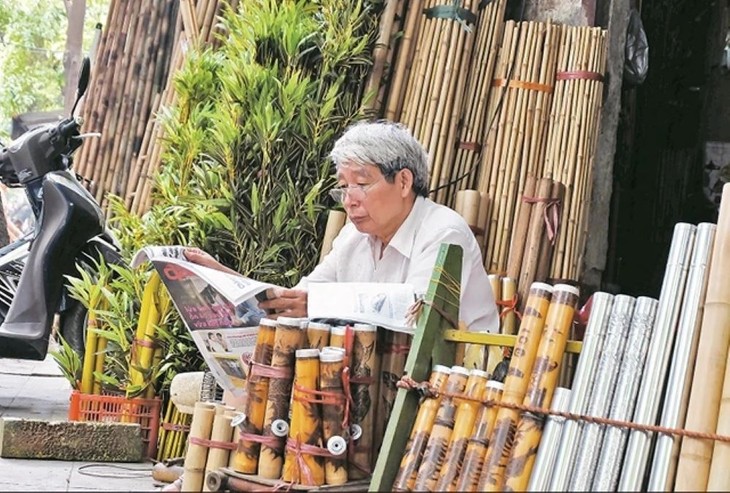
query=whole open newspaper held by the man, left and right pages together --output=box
[132,246,416,396]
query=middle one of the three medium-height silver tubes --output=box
[568,294,636,491]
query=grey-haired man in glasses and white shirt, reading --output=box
[186,122,499,332]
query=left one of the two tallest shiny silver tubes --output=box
[618,223,697,491]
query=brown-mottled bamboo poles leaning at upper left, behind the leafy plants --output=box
[75,0,235,212]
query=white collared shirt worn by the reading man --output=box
[297,197,499,332]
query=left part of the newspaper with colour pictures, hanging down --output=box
[132,246,277,396]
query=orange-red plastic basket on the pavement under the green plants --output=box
[68,390,162,457]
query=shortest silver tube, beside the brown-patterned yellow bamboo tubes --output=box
[527,387,570,491]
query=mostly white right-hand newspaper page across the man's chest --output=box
[307,282,416,334]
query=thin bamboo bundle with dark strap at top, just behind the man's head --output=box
[386,0,479,201]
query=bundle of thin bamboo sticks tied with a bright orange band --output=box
[479,21,562,273]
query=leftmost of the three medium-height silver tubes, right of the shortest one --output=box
[548,292,613,491]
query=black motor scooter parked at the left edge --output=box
[0,58,122,360]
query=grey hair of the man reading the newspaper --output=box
[330,121,428,197]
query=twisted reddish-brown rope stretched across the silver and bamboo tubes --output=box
[396,375,730,443]
